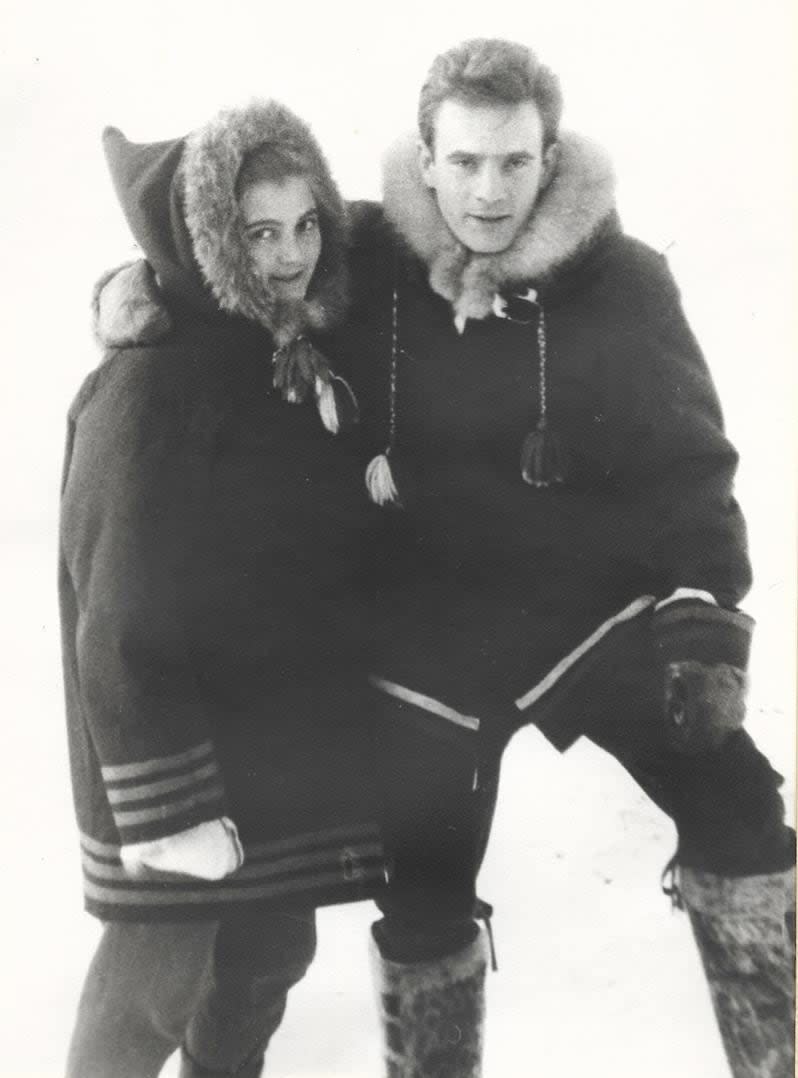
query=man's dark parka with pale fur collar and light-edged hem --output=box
[332,135,751,758]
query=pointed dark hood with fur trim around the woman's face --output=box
[104,101,347,345]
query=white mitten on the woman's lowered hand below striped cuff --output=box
[120,816,244,880]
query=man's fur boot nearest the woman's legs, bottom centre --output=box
[372,930,489,1078]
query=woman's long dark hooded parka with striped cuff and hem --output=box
[60,105,383,920]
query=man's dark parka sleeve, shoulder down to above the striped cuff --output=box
[607,252,751,607]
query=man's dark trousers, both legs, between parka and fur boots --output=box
[373,688,795,962]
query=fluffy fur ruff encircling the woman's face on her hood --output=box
[181,101,347,346]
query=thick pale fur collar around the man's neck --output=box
[384,134,615,332]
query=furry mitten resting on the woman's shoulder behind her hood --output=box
[93,259,171,348]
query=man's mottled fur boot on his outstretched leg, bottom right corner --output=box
[678,868,795,1078]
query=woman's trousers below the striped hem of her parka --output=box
[67,911,316,1078]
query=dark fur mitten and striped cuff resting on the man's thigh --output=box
[652,598,754,756]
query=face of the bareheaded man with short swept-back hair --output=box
[419,97,556,254]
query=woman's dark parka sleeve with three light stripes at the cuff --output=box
[60,357,224,844]
